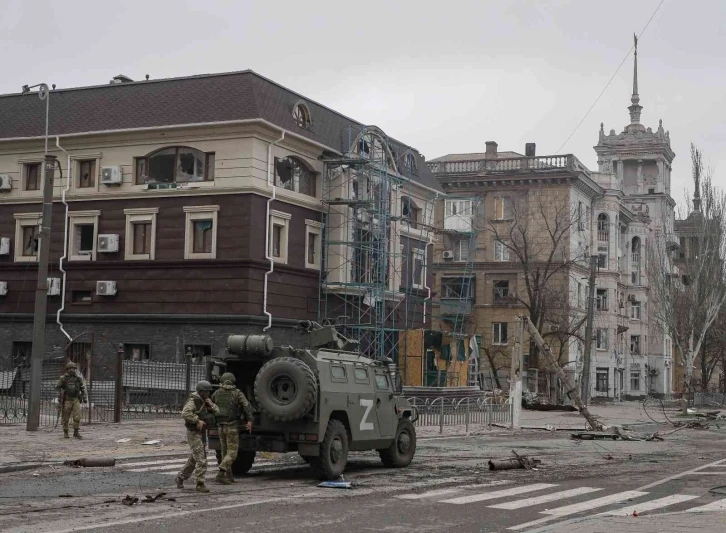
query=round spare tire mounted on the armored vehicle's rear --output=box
[255,357,318,422]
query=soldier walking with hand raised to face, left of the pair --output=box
[176,380,219,492]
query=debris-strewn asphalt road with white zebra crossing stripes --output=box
[0,433,726,533]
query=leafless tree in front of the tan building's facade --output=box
[487,191,584,367]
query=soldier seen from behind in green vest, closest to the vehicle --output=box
[212,372,252,485]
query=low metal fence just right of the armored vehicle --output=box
[409,397,512,433]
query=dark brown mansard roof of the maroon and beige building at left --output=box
[0,70,441,191]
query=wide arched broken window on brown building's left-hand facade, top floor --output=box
[135,146,214,185]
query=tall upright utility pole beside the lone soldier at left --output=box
[26,153,57,431]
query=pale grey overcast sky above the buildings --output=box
[0,0,726,202]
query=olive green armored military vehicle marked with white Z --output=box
[208,321,418,480]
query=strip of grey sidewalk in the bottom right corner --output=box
[538,511,726,533]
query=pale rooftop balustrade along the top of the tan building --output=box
[427,154,590,176]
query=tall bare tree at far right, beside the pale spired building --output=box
[647,144,726,409]
